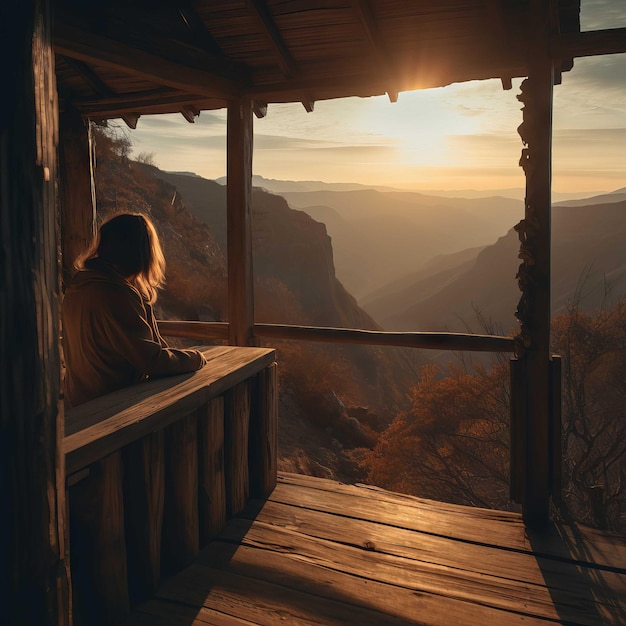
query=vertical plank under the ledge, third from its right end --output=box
[198,396,226,545]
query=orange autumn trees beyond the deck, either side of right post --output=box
[360,299,626,532]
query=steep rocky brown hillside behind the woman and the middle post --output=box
[96,138,416,481]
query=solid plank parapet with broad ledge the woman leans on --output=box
[64,346,277,626]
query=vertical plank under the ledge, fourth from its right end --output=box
[163,413,200,572]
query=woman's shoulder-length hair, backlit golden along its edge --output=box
[76,213,165,303]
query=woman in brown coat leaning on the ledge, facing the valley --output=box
[63,213,206,407]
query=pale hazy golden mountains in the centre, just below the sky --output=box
[282,189,523,301]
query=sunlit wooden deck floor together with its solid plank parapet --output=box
[64,346,626,626]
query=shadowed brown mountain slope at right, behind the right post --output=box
[365,201,626,333]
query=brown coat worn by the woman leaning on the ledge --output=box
[63,259,205,407]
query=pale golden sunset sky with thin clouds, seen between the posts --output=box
[130,0,626,193]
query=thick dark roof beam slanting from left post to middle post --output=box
[54,22,242,97]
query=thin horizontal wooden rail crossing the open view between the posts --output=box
[159,320,515,352]
